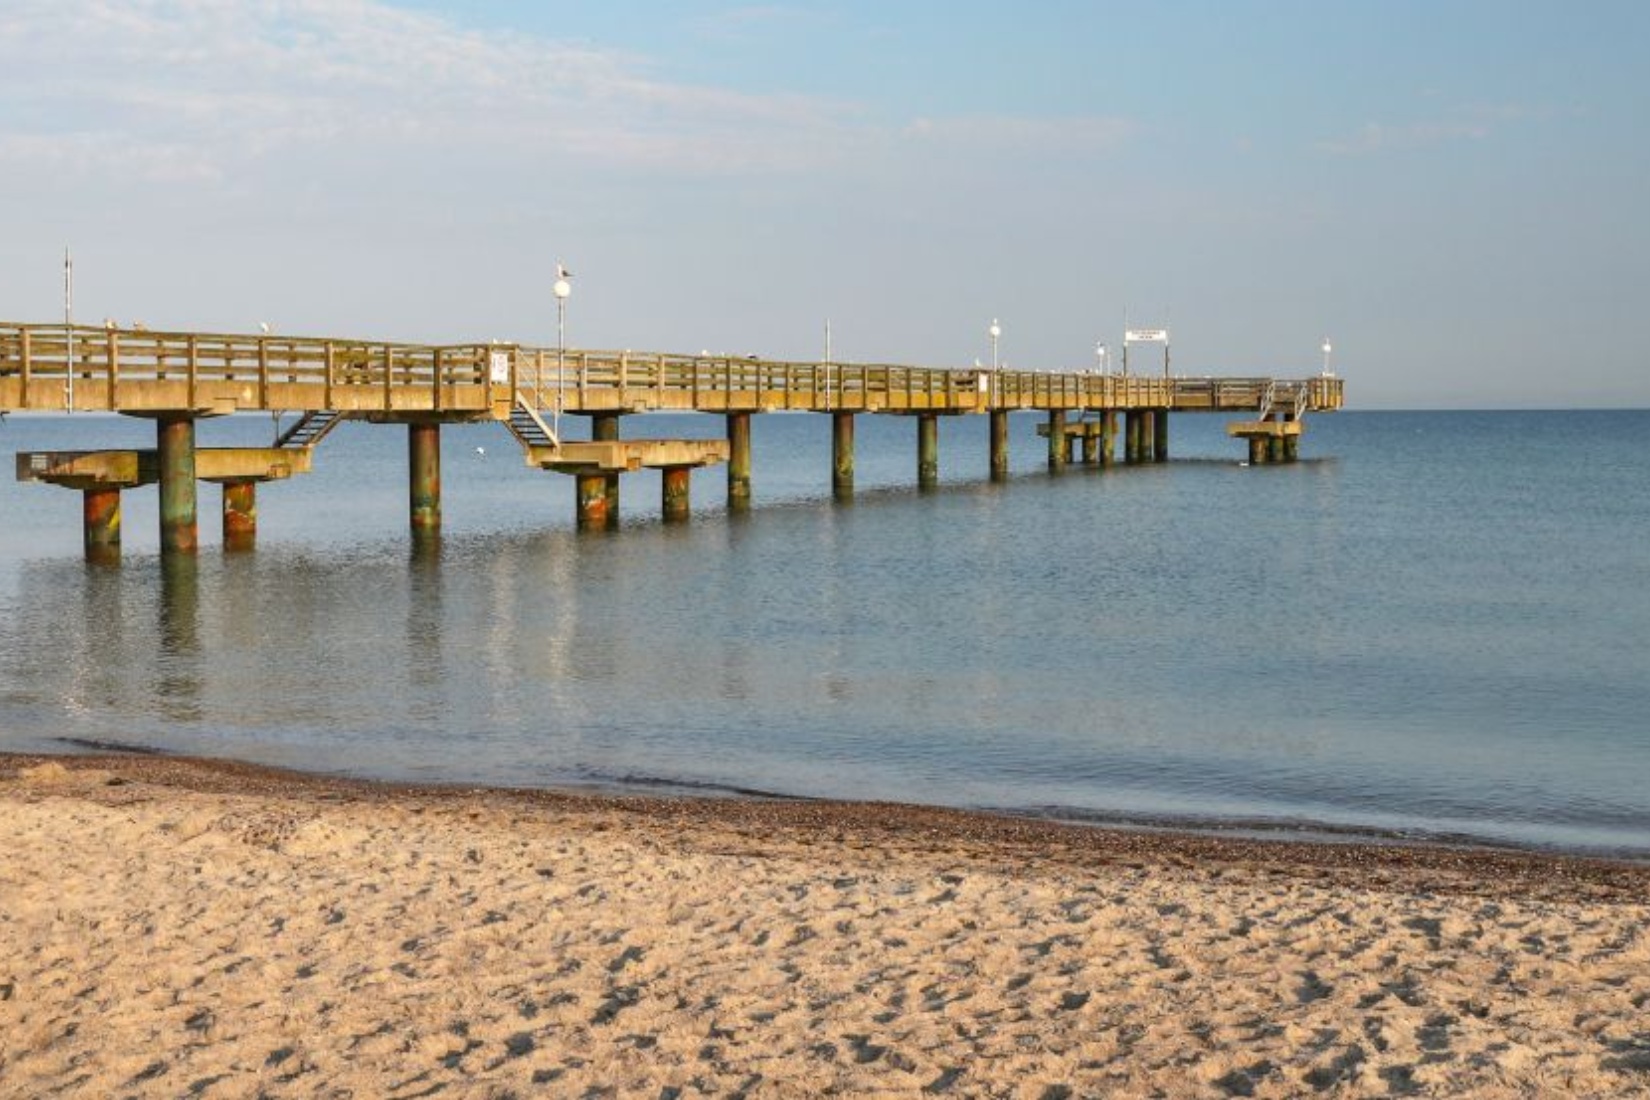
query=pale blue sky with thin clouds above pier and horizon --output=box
[0,0,1650,409]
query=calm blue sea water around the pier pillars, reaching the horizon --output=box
[0,412,1650,858]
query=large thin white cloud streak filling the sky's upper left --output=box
[0,0,846,180]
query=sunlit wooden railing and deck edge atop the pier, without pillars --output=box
[0,323,1341,416]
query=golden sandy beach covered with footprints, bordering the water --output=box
[0,757,1650,1100]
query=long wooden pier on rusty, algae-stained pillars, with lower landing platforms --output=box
[0,323,1343,561]
